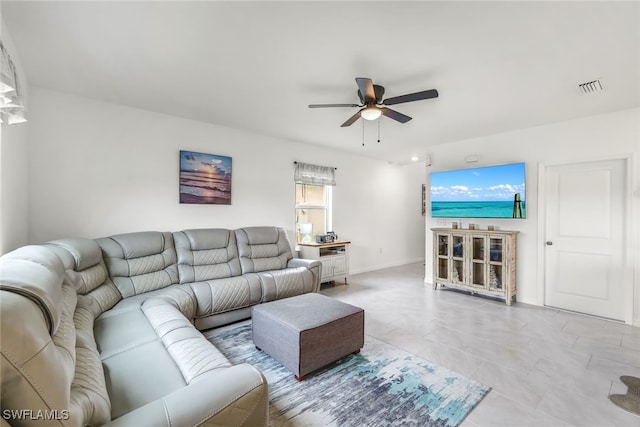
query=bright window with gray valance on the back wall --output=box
[294,162,336,243]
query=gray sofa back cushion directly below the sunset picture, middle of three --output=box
[173,228,242,283]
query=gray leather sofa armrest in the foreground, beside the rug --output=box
[105,363,269,427]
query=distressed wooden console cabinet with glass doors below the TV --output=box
[431,228,518,305]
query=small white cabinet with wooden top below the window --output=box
[299,240,351,285]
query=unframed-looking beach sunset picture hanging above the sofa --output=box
[180,150,231,205]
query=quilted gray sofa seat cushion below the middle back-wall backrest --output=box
[188,274,262,317]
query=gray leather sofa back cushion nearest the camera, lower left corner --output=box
[0,246,80,425]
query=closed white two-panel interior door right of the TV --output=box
[545,160,627,320]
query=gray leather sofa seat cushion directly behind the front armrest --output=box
[94,297,231,418]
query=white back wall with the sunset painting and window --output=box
[23,87,424,272]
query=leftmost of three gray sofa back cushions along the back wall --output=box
[96,231,178,298]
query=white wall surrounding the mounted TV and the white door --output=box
[425,109,640,325]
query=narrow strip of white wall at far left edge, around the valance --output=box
[0,22,29,254]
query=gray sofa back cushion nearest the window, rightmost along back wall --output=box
[236,227,293,274]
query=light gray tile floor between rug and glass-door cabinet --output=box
[321,263,640,427]
